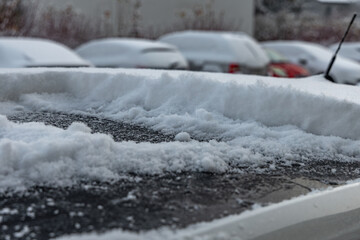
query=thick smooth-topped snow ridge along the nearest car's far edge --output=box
[0,67,360,139]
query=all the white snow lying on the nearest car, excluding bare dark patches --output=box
[0,69,360,191]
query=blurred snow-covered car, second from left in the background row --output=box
[76,38,188,69]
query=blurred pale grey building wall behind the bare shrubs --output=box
[39,0,254,36]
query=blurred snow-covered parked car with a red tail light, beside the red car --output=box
[159,31,269,75]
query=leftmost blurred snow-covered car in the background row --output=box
[0,37,91,68]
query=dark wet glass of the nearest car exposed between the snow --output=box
[0,112,360,240]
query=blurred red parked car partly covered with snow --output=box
[264,48,310,78]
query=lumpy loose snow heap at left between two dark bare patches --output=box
[0,116,261,190]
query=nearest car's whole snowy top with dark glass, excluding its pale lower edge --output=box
[0,68,360,240]
